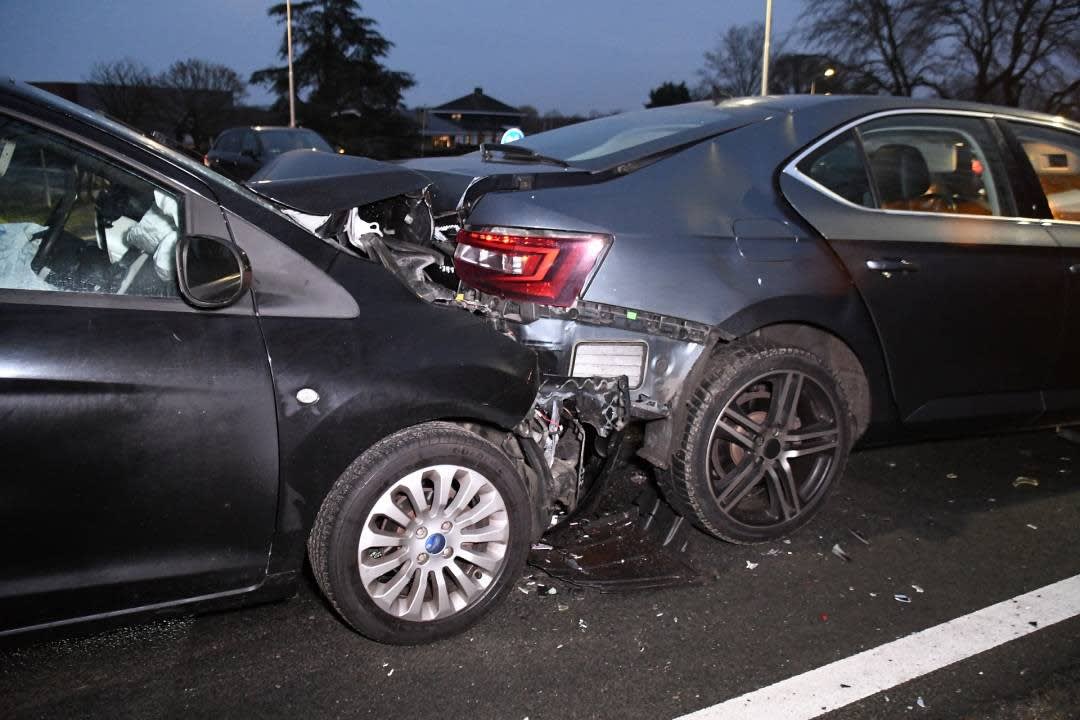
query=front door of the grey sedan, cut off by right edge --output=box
[1003,120,1080,422]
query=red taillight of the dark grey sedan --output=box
[454,228,610,308]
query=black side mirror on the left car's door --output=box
[176,235,252,310]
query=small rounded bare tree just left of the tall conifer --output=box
[158,58,246,142]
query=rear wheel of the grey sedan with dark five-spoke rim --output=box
[665,342,854,543]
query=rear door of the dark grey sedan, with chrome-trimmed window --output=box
[781,111,1065,426]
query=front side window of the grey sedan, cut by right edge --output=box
[1009,122,1080,222]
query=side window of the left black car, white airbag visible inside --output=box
[0,116,181,297]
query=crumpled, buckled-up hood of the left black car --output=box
[247,150,431,215]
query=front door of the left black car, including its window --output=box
[0,111,278,631]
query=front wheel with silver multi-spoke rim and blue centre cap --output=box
[308,422,530,644]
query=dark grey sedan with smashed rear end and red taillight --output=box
[408,96,1080,542]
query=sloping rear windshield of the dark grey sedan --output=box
[505,103,732,163]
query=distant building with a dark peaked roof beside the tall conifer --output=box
[417,87,525,152]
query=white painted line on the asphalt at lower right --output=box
[677,575,1080,720]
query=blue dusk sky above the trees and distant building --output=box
[6,0,802,113]
